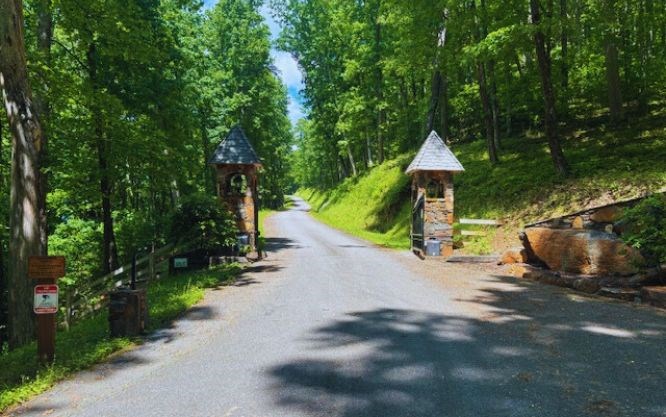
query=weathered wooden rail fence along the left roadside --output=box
[62,240,187,328]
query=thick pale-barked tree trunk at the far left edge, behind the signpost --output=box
[0,0,44,347]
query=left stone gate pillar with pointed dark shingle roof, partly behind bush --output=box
[209,126,262,252]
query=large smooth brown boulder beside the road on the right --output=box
[522,227,644,275]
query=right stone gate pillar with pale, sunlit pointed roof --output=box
[406,131,465,256]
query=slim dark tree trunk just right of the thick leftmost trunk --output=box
[35,0,53,253]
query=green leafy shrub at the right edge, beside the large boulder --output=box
[622,194,666,265]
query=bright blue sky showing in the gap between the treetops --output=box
[204,0,304,126]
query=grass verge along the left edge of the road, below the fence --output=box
[0,265,239,412]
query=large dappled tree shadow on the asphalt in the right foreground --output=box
[269,277,666,417]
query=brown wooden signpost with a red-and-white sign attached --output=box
[28,256,65,363]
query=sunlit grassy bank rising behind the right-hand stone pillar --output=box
[299,109,666,253]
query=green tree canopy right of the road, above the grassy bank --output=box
[273,0,666,189]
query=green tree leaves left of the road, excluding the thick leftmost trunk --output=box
[0,0,292,343]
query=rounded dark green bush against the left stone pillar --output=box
[171,194,238,252]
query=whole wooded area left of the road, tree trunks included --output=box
[0,0,293,348]
